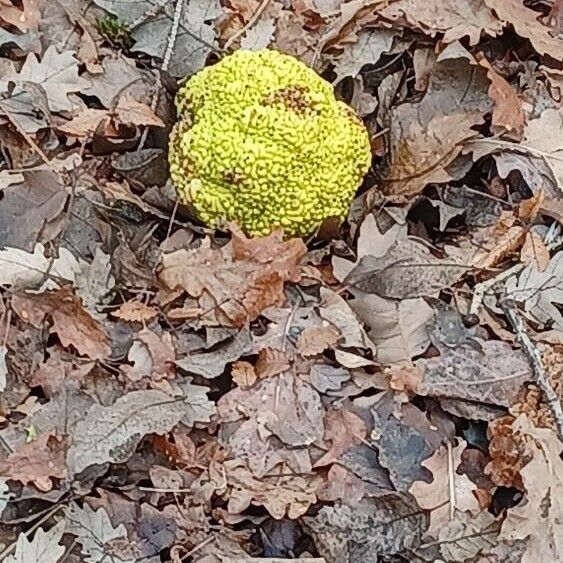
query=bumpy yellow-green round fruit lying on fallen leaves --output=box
[169,50,371,236]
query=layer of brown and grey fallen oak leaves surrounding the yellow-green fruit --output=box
[0,0,563,563]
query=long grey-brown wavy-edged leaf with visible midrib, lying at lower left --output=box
[67,389,207,475]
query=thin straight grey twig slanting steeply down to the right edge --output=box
[497,288,563,442]
